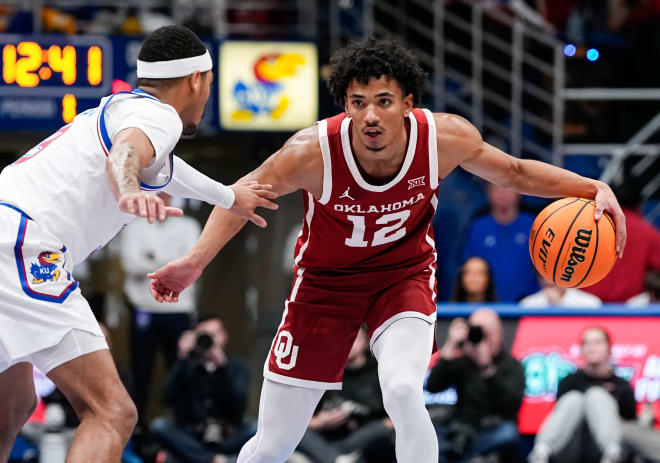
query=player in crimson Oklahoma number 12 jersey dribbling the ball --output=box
[150,38,626,463]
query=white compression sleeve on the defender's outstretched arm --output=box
[164,156,235,209]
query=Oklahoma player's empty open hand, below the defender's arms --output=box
[147,256,202,302]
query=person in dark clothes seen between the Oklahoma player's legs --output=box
[298,328,395,463]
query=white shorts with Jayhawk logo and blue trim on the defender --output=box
[0,203,107,373]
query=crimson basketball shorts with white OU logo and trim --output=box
[264,267,436,389]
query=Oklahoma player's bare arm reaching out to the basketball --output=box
[435,114,626,257]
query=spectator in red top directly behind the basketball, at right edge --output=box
[585,185,660,303]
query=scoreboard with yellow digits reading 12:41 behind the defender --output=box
[0,35,113,130]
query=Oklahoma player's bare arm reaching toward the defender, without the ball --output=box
[148,127,323,302]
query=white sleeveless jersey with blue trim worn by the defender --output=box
[0,90,183,263]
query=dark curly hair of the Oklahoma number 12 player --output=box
[328,36,426,107]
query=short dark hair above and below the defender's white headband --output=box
[137,26,206,90]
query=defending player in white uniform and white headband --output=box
[0,26,276,463]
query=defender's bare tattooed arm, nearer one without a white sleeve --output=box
[106,127,183,223]
